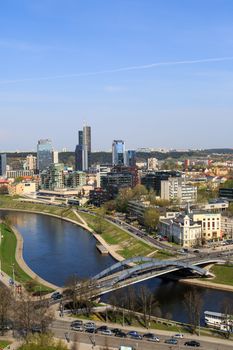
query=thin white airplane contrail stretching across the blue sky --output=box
[0,56,233,84]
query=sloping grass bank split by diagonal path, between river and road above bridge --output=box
[79,212,155,259]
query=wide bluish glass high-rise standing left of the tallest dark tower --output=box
[37,139,53,171]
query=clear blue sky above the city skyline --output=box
[0,0,233,150]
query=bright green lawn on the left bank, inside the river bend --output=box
[0,224,52,292]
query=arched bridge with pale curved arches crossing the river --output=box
[84,257,222,296]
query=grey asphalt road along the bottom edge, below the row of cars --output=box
[51,320,233,350]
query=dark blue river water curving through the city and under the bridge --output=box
[0,212,233,322]
